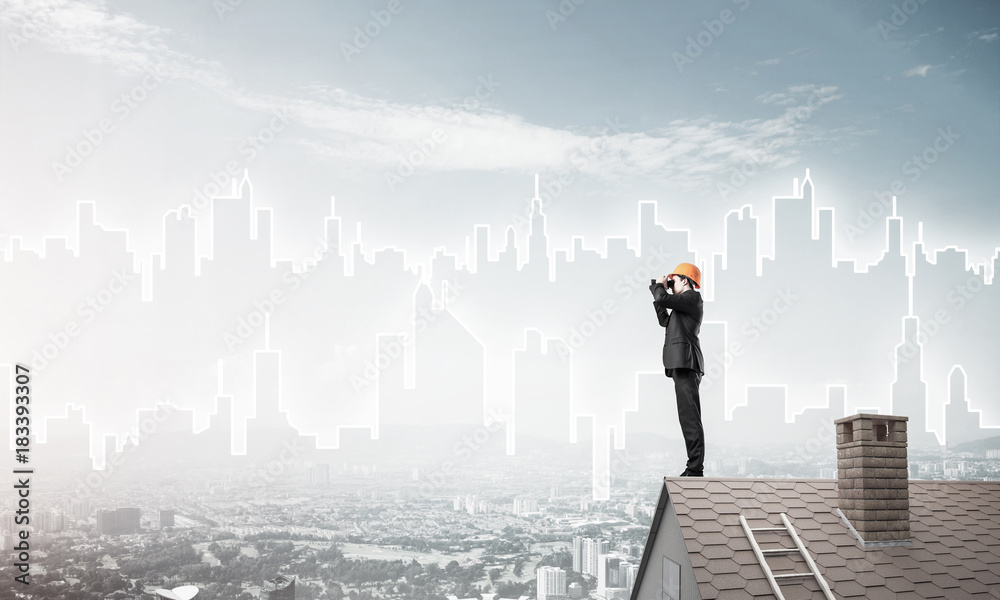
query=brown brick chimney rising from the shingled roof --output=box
[834,413,910,547]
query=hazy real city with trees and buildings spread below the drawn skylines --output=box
[0,420,1000,600]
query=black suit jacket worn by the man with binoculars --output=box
[649,283,705,377]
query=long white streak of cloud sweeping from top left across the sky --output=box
[2,0,860,189]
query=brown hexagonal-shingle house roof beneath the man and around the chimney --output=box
[632,477,1000,600]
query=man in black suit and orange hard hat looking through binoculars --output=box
[649,263,705,477]
